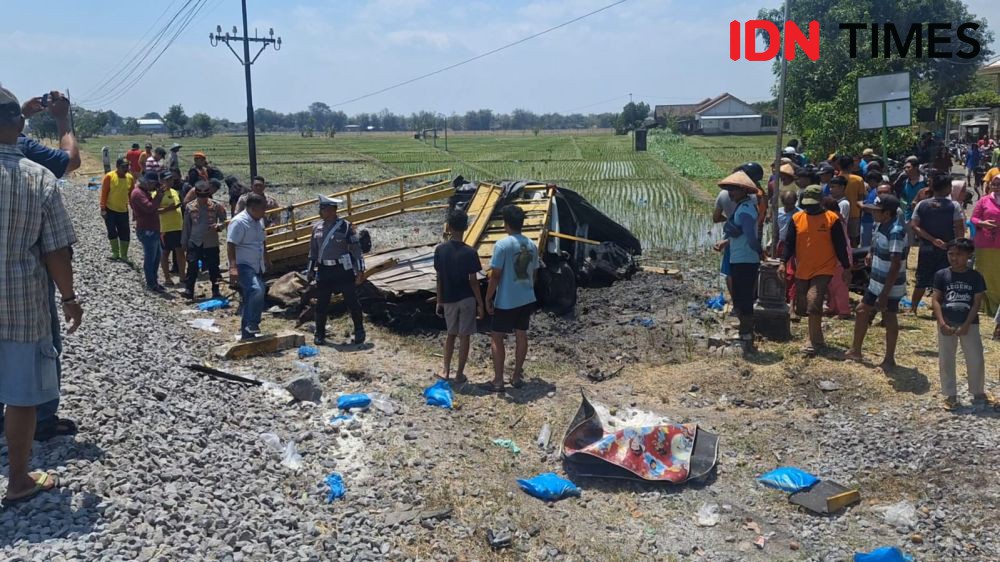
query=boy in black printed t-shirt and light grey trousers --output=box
[933,234,993,411]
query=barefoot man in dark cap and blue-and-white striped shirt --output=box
[847,194,906,372]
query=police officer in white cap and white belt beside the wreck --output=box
[307,195,365,345]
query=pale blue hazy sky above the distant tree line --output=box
[0,0,1000,121]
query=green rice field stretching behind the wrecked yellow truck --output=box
[83,133,773,257]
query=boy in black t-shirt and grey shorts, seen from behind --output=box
[434,209,485,384]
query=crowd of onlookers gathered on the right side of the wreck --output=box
[715,136,1000,409]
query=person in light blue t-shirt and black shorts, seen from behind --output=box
[486,205,538,392]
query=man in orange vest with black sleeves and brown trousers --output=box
[779,185,851,357]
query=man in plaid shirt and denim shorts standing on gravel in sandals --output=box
[0,88,83,507]
